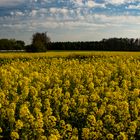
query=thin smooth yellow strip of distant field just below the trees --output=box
[0,51,140,58]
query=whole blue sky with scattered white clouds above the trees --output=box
[0,0,140,44]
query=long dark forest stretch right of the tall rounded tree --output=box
[48,38,140,51]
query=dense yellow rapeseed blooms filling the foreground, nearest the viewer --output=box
[0,53,140,140]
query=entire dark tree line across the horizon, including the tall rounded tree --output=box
[0,32,140,52]
